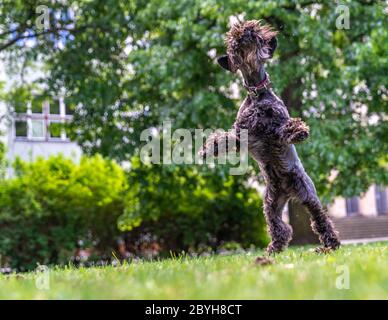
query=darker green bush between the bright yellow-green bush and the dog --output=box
[119,158,267,250]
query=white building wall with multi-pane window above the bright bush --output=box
[6,96,81,175]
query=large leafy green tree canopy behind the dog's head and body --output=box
[0,0,388,232]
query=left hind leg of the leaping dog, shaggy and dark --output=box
[264,186,292,254]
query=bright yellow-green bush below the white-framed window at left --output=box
[0,156,127,270]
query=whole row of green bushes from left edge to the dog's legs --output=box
[0,156,267,270]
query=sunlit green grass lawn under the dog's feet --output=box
[0,243,388,299]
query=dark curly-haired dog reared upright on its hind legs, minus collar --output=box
[201,20,340,253]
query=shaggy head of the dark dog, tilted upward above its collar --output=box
[217,20,277,73]
